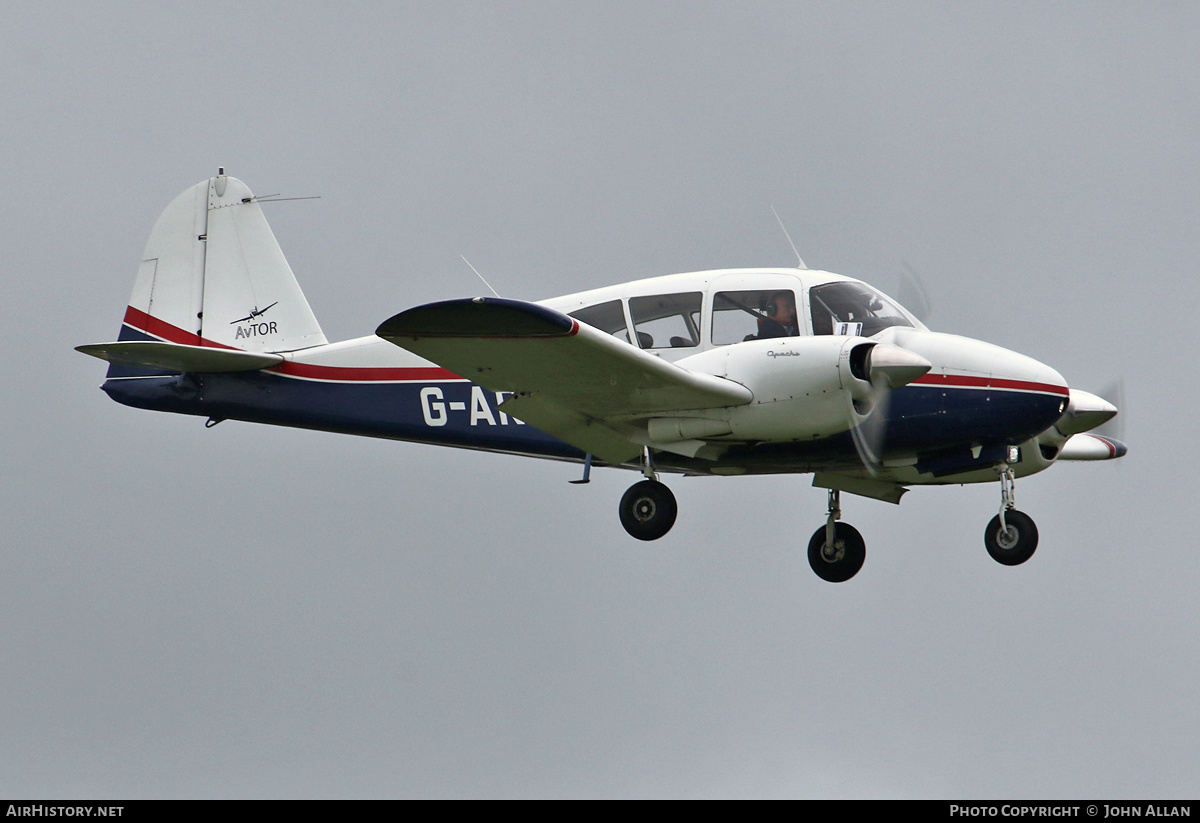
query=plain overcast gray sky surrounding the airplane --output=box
[0,2,1200,798]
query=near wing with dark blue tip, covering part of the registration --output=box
[376,298,754,463]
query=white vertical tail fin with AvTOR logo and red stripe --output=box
[120,169,326,352]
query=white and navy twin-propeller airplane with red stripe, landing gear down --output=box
[79,169,1126,582]
